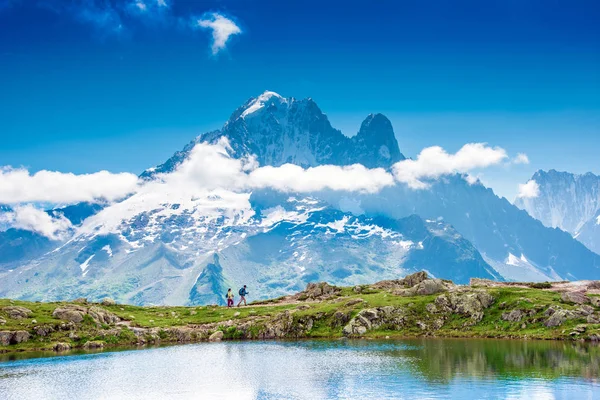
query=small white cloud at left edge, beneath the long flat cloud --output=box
[0,205,72,240]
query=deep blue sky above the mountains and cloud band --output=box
[0,0,600,200]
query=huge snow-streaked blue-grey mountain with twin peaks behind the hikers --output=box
[0,92,600,304]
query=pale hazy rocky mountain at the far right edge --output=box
[515,170,600,254]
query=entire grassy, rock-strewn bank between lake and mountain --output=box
[0,272,600,352]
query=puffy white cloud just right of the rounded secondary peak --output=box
[392,143,508,189]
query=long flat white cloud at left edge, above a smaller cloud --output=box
[0,167,138,204]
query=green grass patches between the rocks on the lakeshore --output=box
[0,286,600,352]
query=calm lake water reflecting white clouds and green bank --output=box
[0,339,600,400]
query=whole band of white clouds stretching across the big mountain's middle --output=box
[0,138,524,239]
